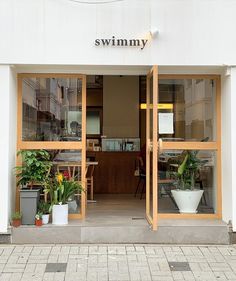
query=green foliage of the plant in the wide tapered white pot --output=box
[172,150,207,190]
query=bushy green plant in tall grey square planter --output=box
[15,150,52,224]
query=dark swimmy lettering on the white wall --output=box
[94,36,148,50]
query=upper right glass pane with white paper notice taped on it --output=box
[159,79,216,141]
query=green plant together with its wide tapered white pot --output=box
[171,150,207,213]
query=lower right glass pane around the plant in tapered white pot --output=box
[158,150,217,214]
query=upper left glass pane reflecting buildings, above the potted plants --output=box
[22,78,82,141]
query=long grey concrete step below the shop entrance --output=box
[12,220,230,244]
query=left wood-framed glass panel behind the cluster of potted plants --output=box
[16,73,86,218]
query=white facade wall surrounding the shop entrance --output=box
[0,0,236,232]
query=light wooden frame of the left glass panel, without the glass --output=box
[15,73,86,219]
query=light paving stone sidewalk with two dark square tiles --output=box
[0,244,236,281]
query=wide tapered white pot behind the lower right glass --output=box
[171,189,203,214]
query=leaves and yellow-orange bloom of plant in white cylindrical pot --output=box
[44,174,83,206]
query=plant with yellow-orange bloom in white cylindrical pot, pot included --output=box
[45,174,83,225]
